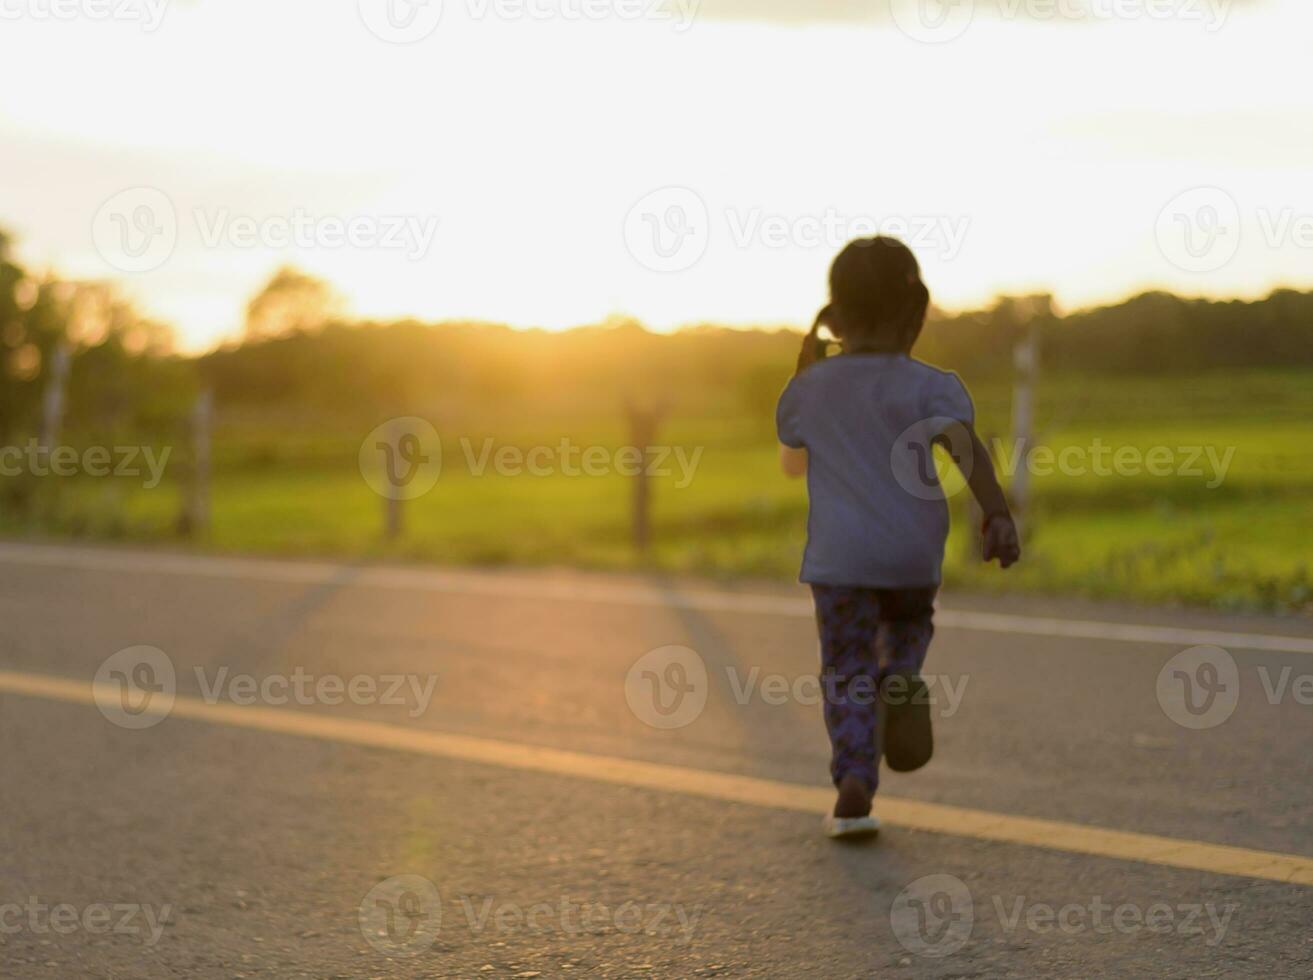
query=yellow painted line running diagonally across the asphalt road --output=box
[0,670,1313,885]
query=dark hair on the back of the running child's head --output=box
[817,235,930,353]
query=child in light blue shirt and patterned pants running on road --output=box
[776,236,1020,837]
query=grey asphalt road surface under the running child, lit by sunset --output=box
[0,545,1313,980]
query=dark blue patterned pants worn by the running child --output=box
[811,585,937,793]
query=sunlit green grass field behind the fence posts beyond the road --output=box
[0,372,1313,612]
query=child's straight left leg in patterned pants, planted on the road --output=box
[811,586,880,800]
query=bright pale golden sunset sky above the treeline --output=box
[0,0,1313,348]
